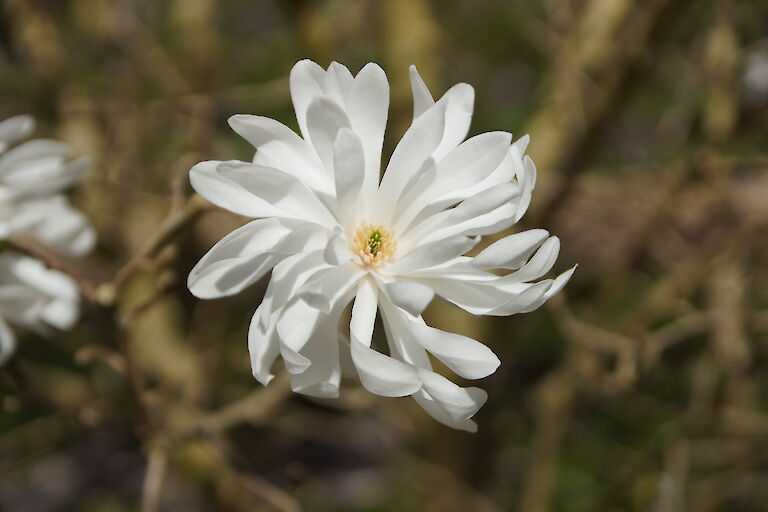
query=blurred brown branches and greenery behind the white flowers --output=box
[0,0,768,512]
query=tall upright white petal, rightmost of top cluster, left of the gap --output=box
[347,63,389,201]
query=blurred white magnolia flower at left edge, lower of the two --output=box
[0,250,79,365]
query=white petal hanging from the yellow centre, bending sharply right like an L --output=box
[350,280,421,396]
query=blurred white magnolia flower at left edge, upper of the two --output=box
[0,116,96,255]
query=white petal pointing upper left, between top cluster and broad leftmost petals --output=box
[224,114,333,193]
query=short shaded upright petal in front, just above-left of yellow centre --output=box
[333,129,365,224]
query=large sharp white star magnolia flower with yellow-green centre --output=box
[189,60,573,431]
